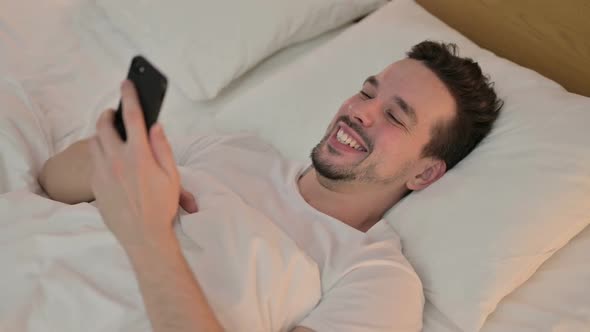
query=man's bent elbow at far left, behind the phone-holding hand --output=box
[38,139,94,204]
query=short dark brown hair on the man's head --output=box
[407,41,504,170]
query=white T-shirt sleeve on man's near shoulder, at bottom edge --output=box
[300,264,424,332]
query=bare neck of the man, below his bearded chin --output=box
[297,166,403,232]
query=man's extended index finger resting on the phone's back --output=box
[121,80,148,149]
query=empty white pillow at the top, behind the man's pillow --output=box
[96,0,386,100]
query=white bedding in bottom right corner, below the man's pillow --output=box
[482,226,590,332]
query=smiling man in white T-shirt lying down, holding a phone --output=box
[40,41,502,332]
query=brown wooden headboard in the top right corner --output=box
[416,0,590,97]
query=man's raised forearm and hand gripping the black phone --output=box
[89,81,222,332]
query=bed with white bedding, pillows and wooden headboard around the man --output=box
[0,0,590,332]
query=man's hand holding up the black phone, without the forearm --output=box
[90,81,182,248]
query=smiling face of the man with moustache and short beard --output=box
[312,59,455,191]
